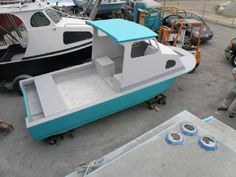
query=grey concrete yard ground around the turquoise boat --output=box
[0,24,236,177]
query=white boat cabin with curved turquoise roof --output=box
[87,19,188,92]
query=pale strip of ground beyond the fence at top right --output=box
[158,0,236,27]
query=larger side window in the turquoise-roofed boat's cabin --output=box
[131,40,158,58]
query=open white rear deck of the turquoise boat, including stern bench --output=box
[24,60,121,122]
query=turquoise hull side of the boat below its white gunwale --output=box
[28,78,176,140]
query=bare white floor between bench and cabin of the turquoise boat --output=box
[54,68,114,109]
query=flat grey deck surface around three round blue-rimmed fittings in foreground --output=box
[77,111,236,177]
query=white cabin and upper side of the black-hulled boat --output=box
[0,2,92,64]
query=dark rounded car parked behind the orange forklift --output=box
[162,13,214,43]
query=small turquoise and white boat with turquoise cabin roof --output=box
[20,19,196,140]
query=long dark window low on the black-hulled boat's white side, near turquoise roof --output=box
[63,31,93,44]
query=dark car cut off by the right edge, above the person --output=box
[225,38,236,67]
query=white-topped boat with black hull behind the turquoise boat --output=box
[0,2,92,90]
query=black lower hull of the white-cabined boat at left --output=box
[0,46,92,82]
